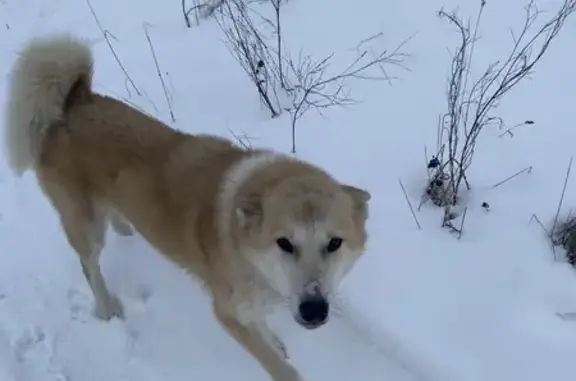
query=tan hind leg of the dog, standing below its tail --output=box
[41,177,124,320]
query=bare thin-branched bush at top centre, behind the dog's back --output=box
[214,0,407,152]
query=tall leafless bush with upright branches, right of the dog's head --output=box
[426,0,576,224]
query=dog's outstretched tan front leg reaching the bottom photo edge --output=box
[214,307,304,381]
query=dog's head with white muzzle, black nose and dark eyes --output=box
[238,168,370,329]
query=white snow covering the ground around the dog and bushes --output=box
[0,0,576,381]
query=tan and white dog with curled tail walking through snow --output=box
[4,34,370,381]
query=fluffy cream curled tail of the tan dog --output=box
[4,35,93,176]
